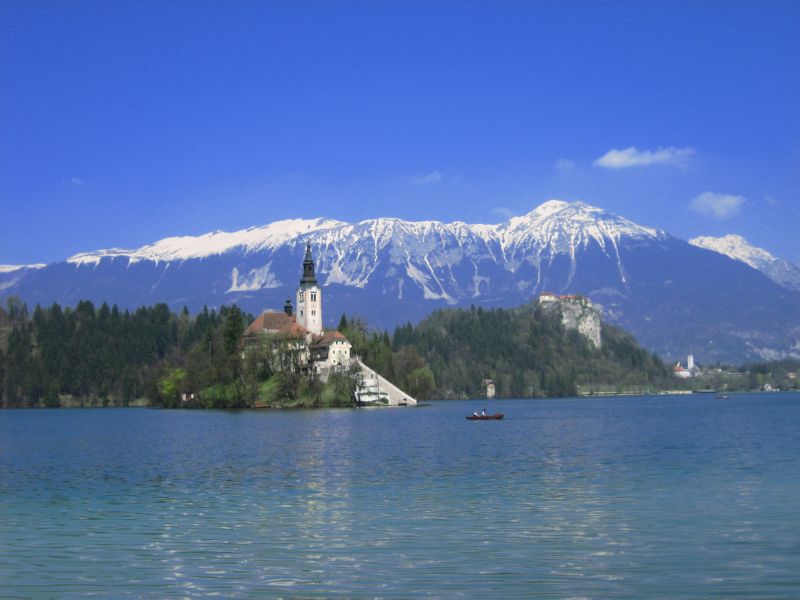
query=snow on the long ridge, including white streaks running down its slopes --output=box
[59,200,666,304]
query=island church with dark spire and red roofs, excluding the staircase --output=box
[245,244,352,378]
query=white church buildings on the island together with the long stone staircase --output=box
[245,243,417,406]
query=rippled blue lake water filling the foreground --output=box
[0,394,800,598]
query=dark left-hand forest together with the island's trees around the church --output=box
[0,298,424,408]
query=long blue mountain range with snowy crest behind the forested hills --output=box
[0,200,800,363]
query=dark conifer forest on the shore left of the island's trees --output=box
[0,298,225,407]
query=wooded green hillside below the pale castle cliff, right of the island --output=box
[384,304,675,398]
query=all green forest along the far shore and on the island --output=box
[0,297,798,408]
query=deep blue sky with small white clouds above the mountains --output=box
[0,0,800,264]
